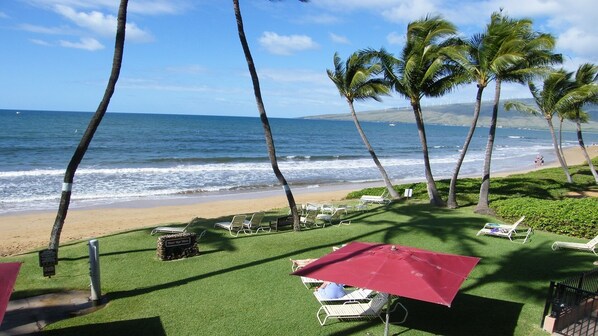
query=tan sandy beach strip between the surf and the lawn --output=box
[0,146,598,256]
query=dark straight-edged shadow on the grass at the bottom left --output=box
[40,316,166,336]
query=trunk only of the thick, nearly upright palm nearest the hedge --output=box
[474,78,502,214]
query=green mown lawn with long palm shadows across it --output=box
[0,200,596,336]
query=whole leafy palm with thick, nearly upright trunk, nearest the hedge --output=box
[474,12,562,214]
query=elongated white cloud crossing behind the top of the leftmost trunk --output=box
[55,5,153,42]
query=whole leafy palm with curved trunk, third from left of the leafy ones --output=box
[447,16,517,209]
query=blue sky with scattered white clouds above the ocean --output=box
[0,0,598,118]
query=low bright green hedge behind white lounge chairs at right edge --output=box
[492,197,598,239]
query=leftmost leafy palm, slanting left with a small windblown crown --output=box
[326,53,399,198]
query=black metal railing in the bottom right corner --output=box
[542,268,598,336]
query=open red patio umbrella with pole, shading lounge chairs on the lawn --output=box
[291,242,480,334]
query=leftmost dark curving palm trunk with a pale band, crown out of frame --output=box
[48,0,128,251]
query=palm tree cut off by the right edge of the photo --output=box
[573,63,598,184]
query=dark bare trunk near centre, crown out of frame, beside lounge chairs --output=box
[233,0,301,231]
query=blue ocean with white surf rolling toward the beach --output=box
[0,110,598,214]
